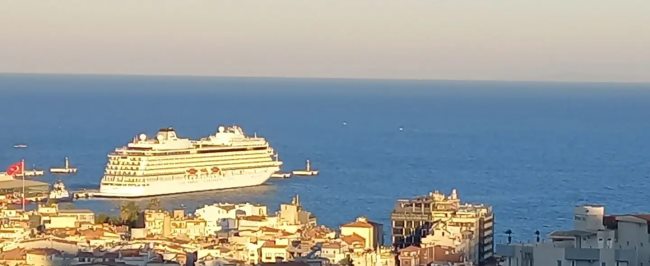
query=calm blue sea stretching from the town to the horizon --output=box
[0,74,650,242]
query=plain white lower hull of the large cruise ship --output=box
[94,168,278,198]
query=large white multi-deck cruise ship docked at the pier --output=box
[94,126,282,198]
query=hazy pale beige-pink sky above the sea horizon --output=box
[0,0,650,81]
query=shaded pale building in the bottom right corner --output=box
[497,205,650,266]
